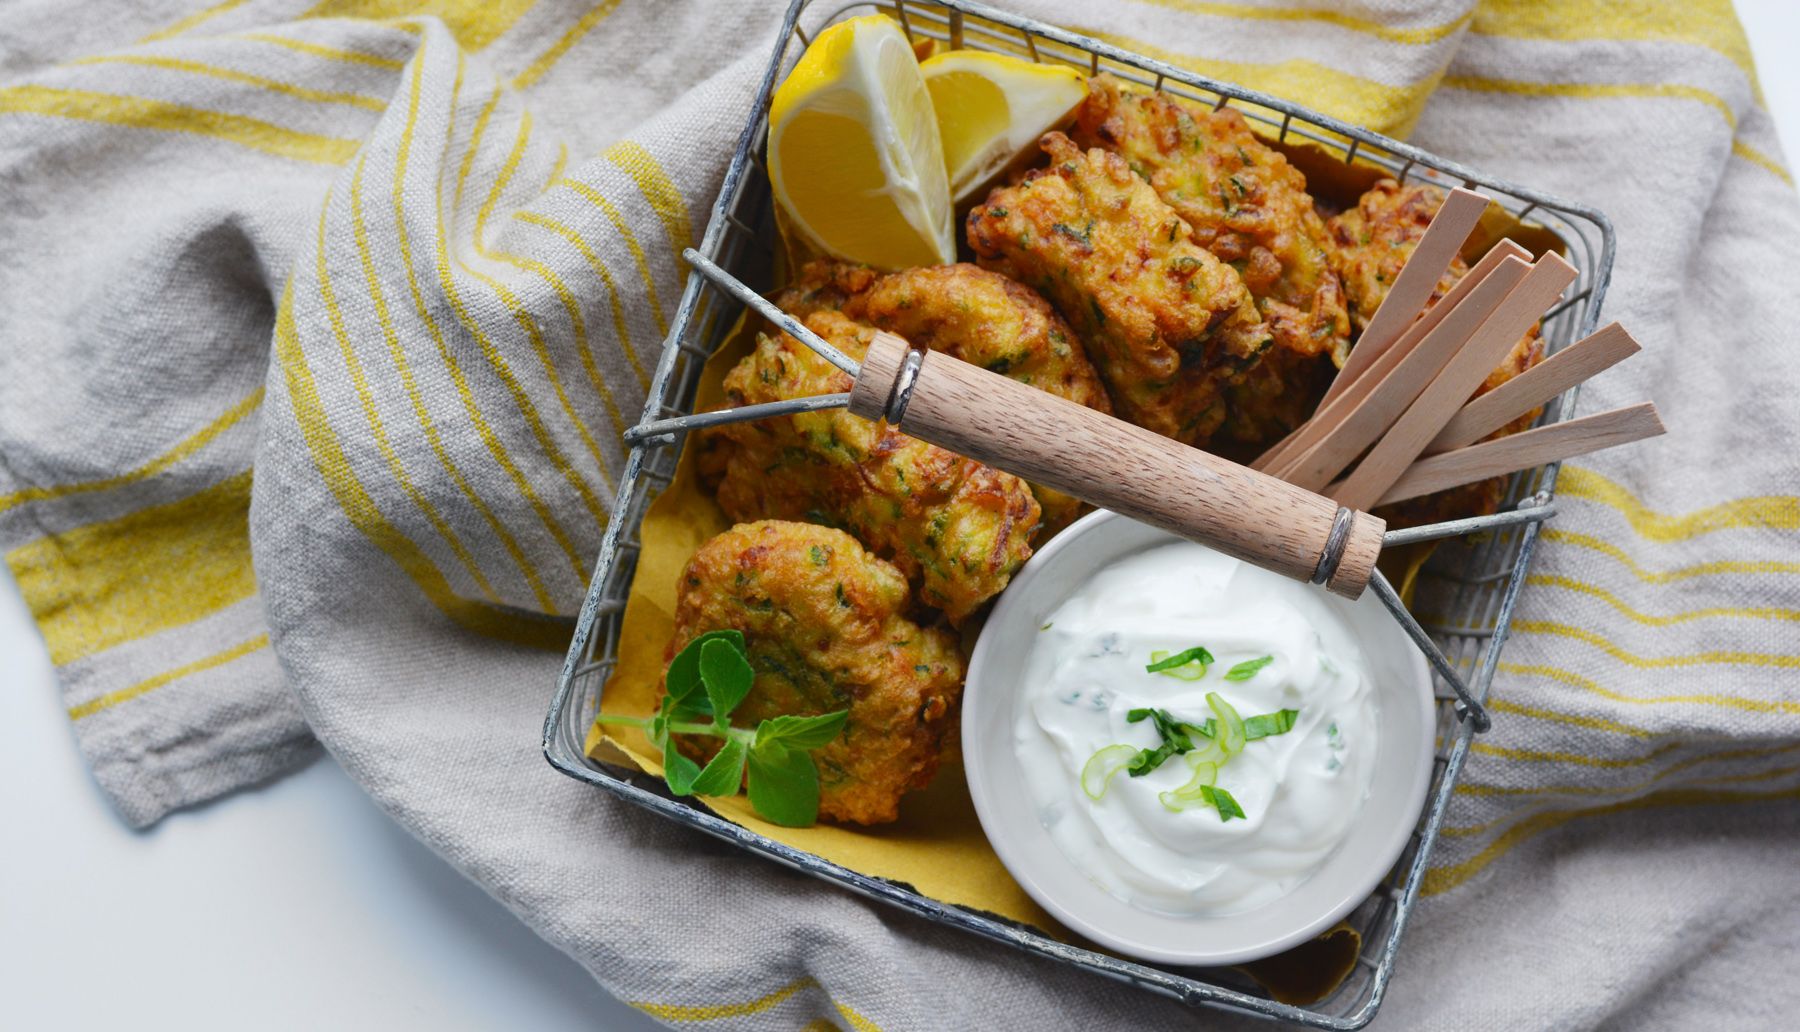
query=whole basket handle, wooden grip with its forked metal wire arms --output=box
[625,249,1555,731]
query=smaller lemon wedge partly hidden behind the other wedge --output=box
[918,50,1087,204]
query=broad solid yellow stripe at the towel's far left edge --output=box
[5,470,256,666]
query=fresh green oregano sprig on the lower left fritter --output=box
[599,630,850,828]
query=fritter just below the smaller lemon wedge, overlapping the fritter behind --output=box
[968,133,1269,445]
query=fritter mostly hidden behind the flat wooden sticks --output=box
[1330,180,1544,528]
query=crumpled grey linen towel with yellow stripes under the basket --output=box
[0,0,1800,1028]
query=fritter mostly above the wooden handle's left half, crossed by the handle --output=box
[844,263,1112,540]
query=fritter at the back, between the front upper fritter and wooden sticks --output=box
[1073,74,1350,445]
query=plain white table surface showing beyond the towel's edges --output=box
[0,0,1800,1032]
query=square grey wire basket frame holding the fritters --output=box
[544,0,1615,1028]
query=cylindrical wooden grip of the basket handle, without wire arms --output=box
[850,325,1386,598]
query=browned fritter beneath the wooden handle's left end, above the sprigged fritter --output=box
[707,312,1039,623]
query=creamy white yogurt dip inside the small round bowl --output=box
[1013,542,1381,917]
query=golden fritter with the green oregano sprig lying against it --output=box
[668,521,963,825]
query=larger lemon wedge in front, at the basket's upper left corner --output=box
[769,14,956,268]
